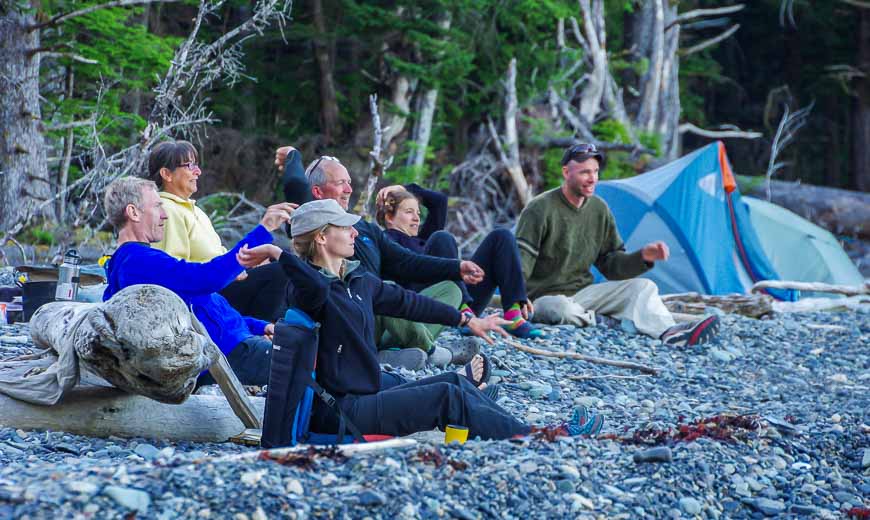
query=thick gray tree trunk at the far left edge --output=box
[0,6,54,231]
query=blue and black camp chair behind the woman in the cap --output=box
[260,309,391,448]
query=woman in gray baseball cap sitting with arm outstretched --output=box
[238,199,601,439]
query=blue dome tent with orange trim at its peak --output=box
[596,142,797,300]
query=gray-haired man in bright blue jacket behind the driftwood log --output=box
[103,177,292,386]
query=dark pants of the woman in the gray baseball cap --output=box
[311,372,530,439]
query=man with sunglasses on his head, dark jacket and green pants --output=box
[275,147,484,369]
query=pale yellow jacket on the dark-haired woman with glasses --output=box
[151,191,227,262]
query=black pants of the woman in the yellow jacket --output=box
[220,262,289,323]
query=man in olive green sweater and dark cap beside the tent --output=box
[517,144,718,345]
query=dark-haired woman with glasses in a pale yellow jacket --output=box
[148,141,287,322]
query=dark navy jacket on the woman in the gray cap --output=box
[278,252,460,397]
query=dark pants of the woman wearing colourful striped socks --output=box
[413,228,528,314]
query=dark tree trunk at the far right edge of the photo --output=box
[852,9,870,191]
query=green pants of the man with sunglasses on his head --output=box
[375,282,462,352]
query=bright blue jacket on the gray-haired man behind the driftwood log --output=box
[103,226,272,354]
